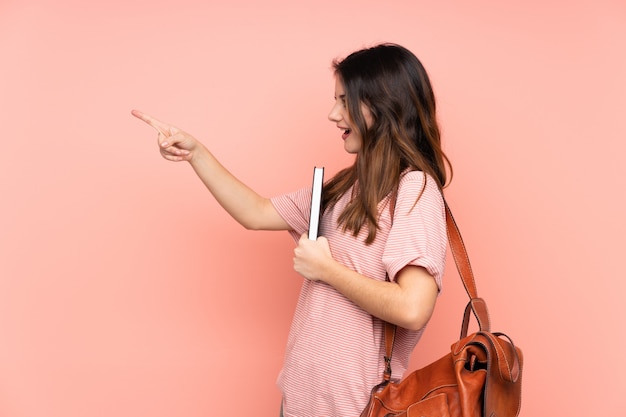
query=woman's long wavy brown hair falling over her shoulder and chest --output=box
[322,43,452,244]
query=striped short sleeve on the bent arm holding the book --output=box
[383,171,447,290]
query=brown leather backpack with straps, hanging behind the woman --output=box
[361,204,523,417]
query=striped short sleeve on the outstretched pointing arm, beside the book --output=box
[270,187,311,241]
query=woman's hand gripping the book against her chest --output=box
[293,233,334,281]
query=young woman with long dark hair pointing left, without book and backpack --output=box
[133,44,449,417]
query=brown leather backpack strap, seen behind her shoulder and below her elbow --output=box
[383,199,491,374]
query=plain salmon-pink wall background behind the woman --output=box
[0,0,626,417]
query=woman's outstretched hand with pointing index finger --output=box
[131,110,201,162]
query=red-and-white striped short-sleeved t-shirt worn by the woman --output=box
[272,171,447,417]
